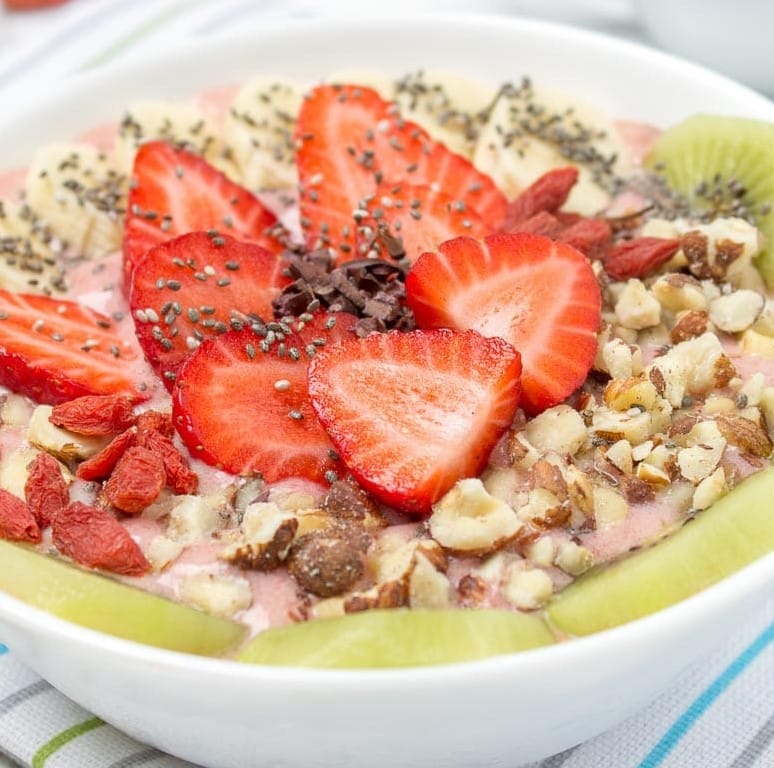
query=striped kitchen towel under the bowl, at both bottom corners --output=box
[0,598,774,768]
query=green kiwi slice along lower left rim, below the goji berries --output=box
[0,541,247,656]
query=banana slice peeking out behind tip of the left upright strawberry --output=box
[115,101,234,178]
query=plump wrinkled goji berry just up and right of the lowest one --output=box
[105,445,167,515]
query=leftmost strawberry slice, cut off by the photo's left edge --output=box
[0,290,147,405]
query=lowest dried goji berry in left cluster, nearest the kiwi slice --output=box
[51,501,150,576]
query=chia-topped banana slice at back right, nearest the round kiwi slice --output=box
[473,80,630,215]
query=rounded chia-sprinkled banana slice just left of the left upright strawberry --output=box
[25,144,128,258]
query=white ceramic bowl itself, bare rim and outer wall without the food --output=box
[0,17,774,768]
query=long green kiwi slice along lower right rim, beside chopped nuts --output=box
[548,468,774,635]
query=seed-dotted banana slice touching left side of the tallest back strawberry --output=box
[225,76,302,190]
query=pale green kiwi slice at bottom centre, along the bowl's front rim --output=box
[238,609,554,668]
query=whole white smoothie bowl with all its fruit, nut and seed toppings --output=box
[0,13,774,766]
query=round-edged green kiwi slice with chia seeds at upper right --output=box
[645,115,774,288]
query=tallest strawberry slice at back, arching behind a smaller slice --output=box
[296,85,507,259]
